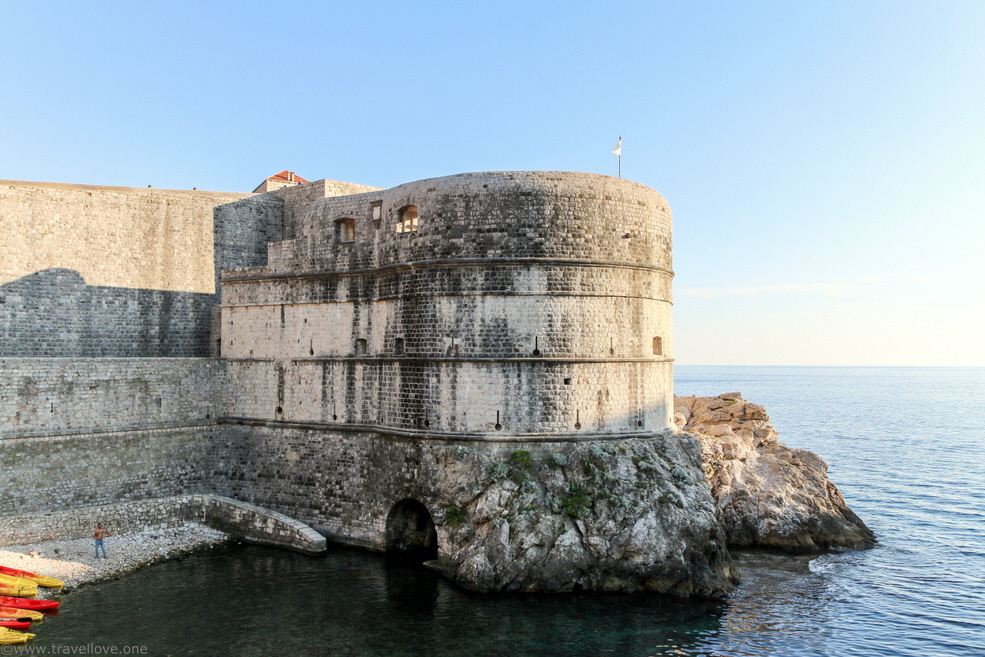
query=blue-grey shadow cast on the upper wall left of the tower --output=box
[0,269,218,358]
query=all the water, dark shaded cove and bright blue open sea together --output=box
[23,367,985,657]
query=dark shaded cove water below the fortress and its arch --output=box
[36,546,729,657]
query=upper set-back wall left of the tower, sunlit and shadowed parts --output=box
[0,180,248,357]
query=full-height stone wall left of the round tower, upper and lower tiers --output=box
[0,181,374,544]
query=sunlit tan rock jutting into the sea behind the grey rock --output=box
[674,392,875,551]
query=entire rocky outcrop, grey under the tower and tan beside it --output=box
[408,393,875,597]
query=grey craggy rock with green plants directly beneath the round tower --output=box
[428,432,737,597]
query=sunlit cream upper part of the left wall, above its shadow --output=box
[0,180,250,294]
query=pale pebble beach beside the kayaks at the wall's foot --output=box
[0,525,232,599]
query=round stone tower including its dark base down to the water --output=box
[210,172,673,550]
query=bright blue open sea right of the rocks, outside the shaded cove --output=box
[676,367,985,656]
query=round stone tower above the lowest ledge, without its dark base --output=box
[223,172,673,440]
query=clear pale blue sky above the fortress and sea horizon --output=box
[0,0,985,366]
